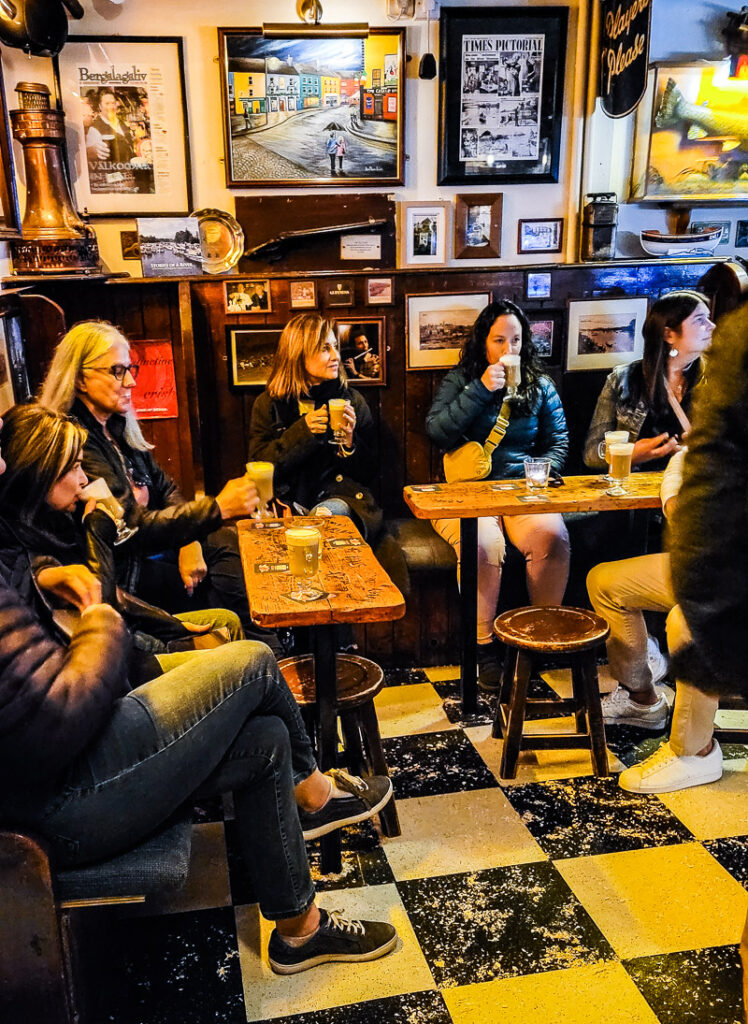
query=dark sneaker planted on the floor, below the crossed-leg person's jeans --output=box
[267,908,398,974]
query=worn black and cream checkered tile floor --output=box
[78,669,748,1024]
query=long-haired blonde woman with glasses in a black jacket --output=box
[39,321,279,650]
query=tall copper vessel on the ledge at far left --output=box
[10,82,100,273]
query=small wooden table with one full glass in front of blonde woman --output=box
[238,516,405,872]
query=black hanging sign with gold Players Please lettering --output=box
[599,0,652,118]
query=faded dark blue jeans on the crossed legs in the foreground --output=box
[12,640,317,920]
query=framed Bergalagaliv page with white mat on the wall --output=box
[55,36,192,217]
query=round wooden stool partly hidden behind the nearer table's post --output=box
[278,654,400,838]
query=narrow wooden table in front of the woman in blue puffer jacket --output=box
[403,473,662,714]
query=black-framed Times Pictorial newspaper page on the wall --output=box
[439,7,569,185]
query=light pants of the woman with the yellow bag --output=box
[431,513,569,643]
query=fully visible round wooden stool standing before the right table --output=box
[492,605,610,778]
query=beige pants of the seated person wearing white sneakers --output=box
[587,554,718,757]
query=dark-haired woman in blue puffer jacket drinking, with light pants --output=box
[426,299,569,689]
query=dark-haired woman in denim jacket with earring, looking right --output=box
[584,290,714,470]
